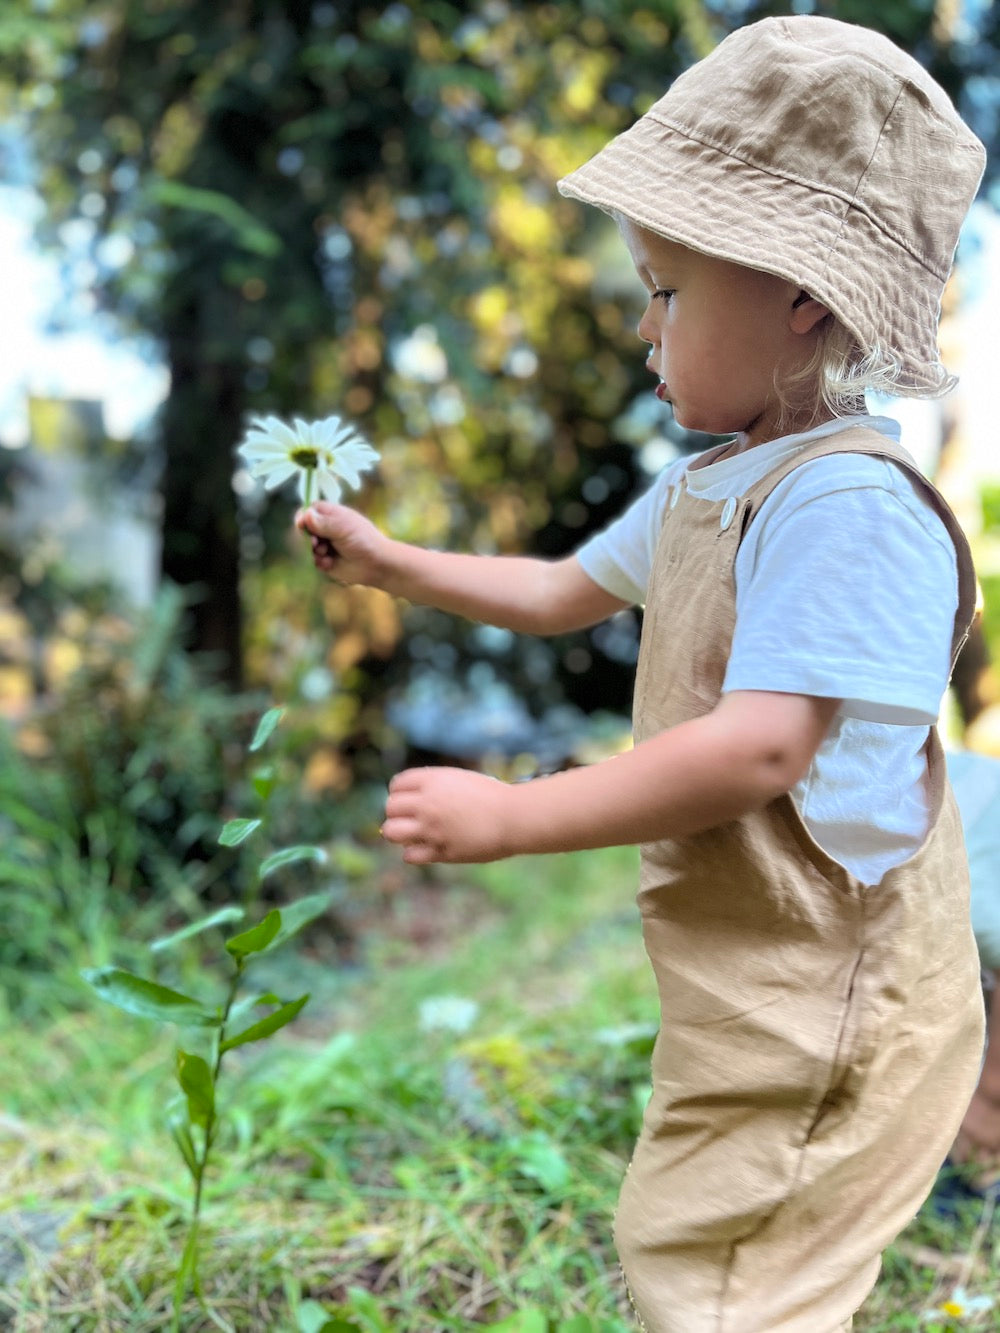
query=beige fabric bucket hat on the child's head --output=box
[559,16,985,396]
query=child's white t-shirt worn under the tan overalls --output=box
[577,417,959,884]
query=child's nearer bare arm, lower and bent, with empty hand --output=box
[383,690,840,864]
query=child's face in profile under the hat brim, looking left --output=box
[619,219,816,447]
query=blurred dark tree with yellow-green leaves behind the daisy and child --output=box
[0,0,999,725]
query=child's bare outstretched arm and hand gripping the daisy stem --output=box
[295,501,628,635]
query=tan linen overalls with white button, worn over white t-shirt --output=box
[624,428,984,1333]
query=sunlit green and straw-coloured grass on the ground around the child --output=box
[0,850,1000,1333]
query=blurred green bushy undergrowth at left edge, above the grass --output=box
[0,587,247,1020]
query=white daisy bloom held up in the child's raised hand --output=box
[237,416,379,505]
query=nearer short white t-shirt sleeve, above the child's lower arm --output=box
[723,456,959,725]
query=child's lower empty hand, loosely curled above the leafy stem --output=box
[381,768,516,865]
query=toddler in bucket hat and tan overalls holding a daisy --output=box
[296,17,984,1333]
